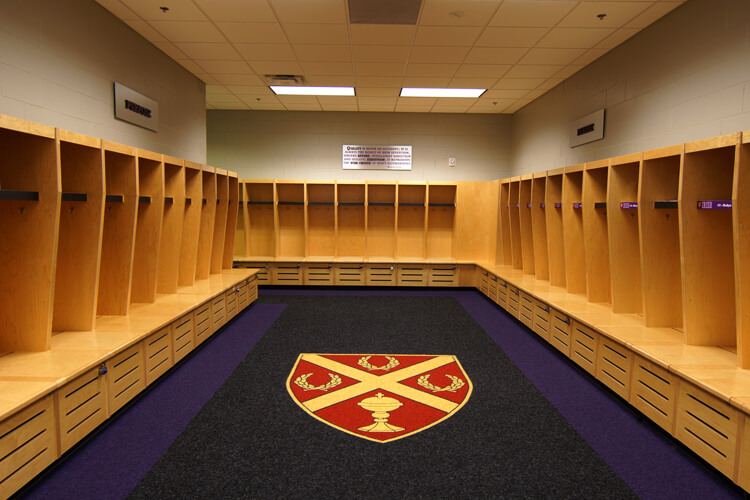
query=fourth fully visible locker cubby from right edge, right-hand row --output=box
[580,160,612,303]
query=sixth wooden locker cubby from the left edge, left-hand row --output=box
[177,161,203,286]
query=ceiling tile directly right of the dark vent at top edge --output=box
[419,0,501,26]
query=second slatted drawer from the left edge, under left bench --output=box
[55,368,109,454]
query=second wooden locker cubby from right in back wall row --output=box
[396,183,427,259]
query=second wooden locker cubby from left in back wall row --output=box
[276,181,306,259]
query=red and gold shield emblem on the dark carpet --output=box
[287,354,472,443]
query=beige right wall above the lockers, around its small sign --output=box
[511,0,750,175]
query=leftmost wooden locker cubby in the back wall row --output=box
[245,180,276,259]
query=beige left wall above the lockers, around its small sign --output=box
[0,0,206,163]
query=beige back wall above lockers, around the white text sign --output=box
[207,110,510,181]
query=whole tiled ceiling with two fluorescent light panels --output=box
[96,0,685,113]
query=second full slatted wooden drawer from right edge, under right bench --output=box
[630,356,679,434]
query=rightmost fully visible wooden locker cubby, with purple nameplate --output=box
[679,134,739,348]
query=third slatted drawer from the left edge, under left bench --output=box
[107,342,146,415]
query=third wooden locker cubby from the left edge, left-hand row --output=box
[96,141,138,316]
